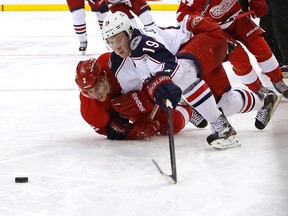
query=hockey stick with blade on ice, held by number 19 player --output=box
[152,100,177,184]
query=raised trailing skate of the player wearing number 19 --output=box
[255,93,282,130]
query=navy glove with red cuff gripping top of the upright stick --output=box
[147,72,182,110]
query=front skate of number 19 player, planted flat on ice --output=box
[207,115,241,150]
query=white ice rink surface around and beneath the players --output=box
[0,12,288,216]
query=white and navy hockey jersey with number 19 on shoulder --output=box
[110,21,191,93]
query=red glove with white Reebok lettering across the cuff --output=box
[111,91,154,118]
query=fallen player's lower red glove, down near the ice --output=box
[127,118,160,140]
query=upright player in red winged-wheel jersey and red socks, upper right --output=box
[177,0,288,98]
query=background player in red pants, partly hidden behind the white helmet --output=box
[104,0,154,28]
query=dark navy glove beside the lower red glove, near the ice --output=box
[106,116,130,140]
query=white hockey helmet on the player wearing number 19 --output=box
[101,11,133,40]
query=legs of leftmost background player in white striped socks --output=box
[66,0,109,55]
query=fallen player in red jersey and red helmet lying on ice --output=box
[75,53,199,140]
